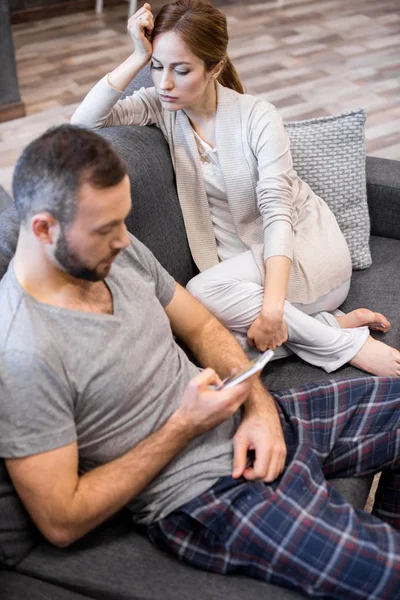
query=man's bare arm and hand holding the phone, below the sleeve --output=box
[6,369,251,547]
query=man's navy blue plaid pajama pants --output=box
[148,377,400,600]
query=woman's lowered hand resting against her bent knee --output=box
[247,310,288,352]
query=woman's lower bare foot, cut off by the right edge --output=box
[350,336,400,377]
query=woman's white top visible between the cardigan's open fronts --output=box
[193,130,248,260]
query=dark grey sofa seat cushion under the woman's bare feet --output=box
[263,236,400,390]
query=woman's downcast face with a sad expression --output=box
[151,31,213,111]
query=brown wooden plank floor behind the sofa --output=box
[0,0,400,189]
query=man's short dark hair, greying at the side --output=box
[13,125,126,227]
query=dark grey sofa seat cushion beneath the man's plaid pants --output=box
[14,510,304,600]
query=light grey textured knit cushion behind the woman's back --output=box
[285,109,371,269]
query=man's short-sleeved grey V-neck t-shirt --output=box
[0,238,237,524]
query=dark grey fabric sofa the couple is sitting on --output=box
[0,85,400,600]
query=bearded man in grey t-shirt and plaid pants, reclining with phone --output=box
[0,126,400,599]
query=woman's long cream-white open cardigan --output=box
[71,77,351,304]
